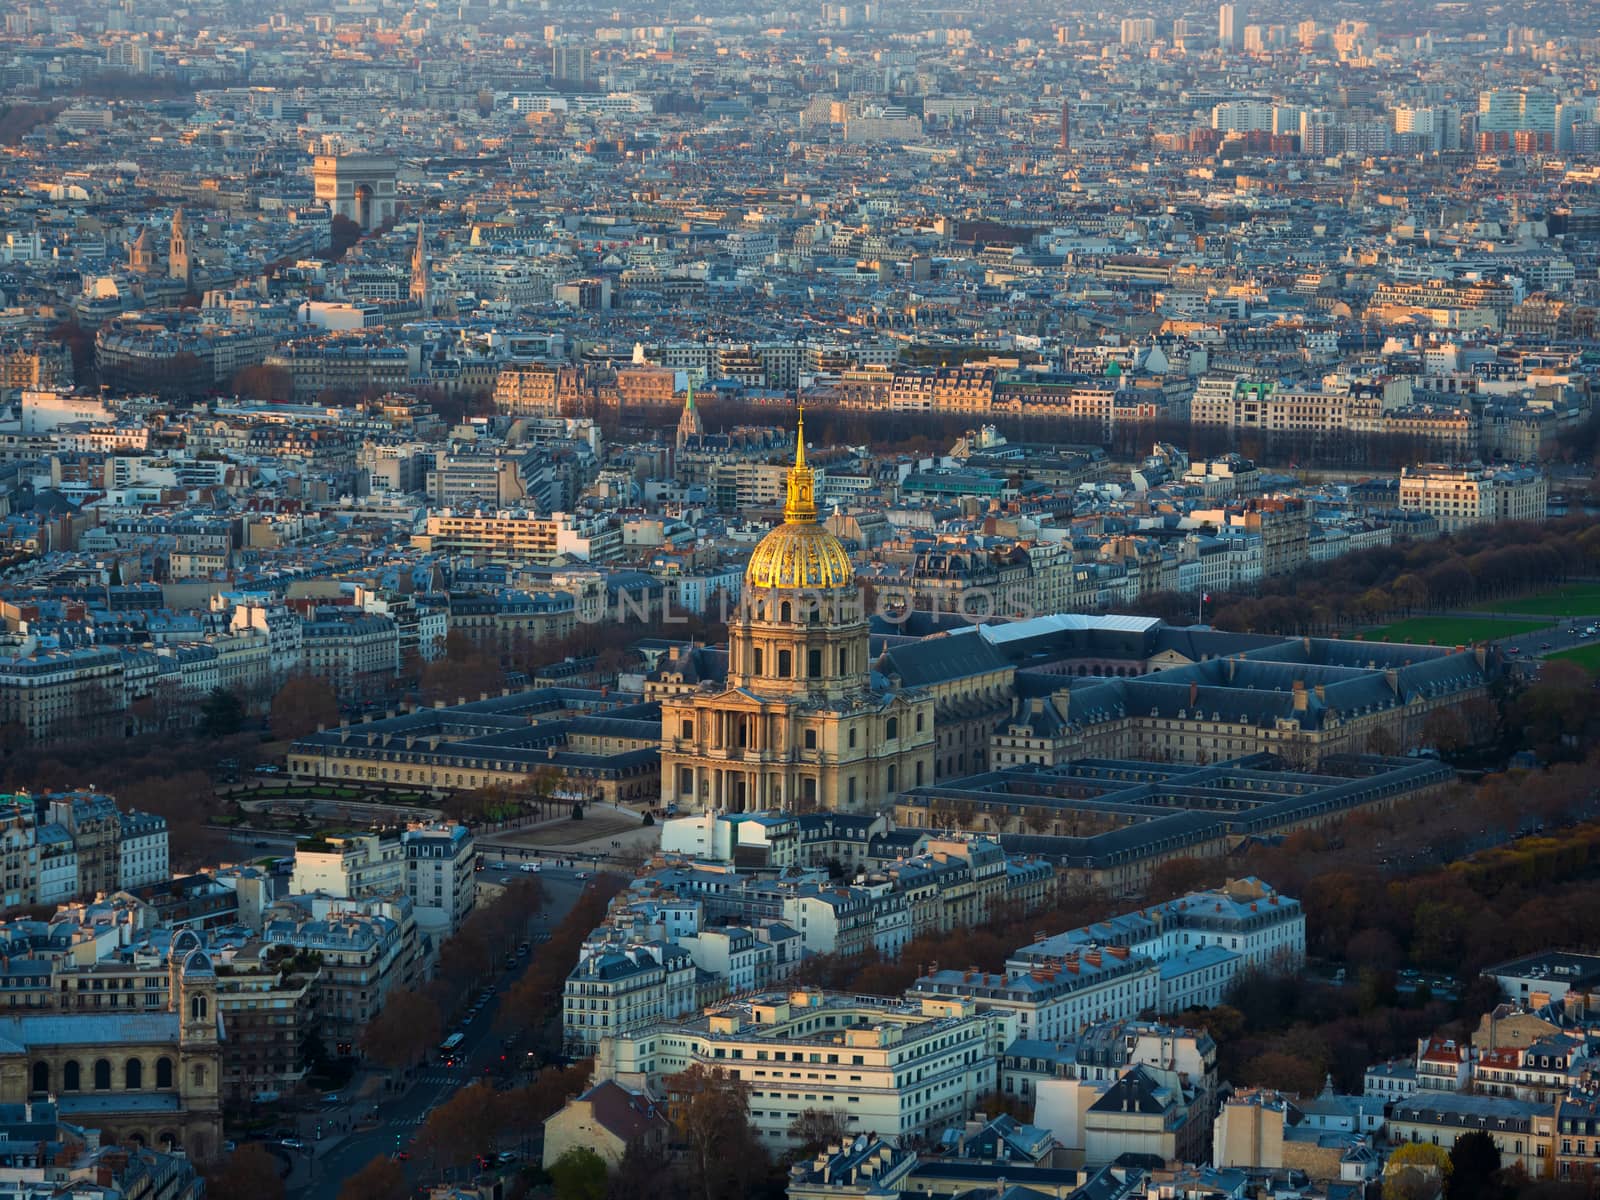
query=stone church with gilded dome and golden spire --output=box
[659,418,934,813]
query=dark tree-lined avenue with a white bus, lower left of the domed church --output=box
[290,867,584,1200]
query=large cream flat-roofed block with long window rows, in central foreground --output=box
[595,990,1014,1152]
